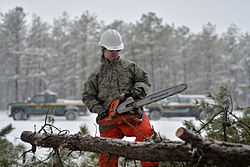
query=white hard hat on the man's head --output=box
[99,29,124,50]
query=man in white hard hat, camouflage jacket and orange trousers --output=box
[82,29,158,167]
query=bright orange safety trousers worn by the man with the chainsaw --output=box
[99,112,159,167]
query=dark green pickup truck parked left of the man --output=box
[8,91,88,120]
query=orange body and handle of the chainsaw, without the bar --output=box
[98,99,141,125]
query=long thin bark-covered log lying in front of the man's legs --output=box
[21,131,192,162]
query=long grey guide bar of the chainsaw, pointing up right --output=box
[117,84,187,114]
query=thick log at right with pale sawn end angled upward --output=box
[176,127,250,167]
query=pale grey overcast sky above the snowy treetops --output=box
[0,0,250,33]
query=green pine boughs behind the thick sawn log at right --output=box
[184,87,250,144]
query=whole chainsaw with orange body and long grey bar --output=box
[98,84,187,125]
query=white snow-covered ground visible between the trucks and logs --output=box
[0,111,195,151]
